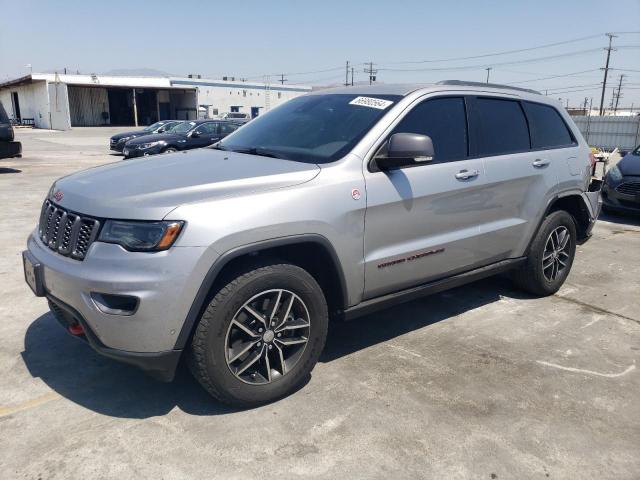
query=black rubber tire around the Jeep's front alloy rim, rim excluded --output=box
[188,261,328,408]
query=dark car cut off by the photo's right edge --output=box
[602,145,640,213]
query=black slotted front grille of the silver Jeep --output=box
[38,200,100,260]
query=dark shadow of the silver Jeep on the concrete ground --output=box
[22,277,532,419]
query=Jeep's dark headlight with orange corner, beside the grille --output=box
[98,220,184,252]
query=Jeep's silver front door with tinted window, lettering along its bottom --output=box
[364,97,490,298]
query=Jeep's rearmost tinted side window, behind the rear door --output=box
[524,102,574,148]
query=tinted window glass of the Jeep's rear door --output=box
[474,98,530,156]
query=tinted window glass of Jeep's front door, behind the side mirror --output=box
[393,97,467,163]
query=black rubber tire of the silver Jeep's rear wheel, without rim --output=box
[512,210,576,296]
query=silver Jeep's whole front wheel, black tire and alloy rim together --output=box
[188,260,328,407]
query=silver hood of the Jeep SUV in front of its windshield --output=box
[50,148,320,220]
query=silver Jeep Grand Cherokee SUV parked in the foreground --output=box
[23,81,600,406]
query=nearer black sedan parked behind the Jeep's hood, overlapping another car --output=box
[123,120,242,158]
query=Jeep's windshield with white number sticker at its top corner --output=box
[218,94,401,163]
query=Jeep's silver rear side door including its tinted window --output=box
[469,97,558,261]
